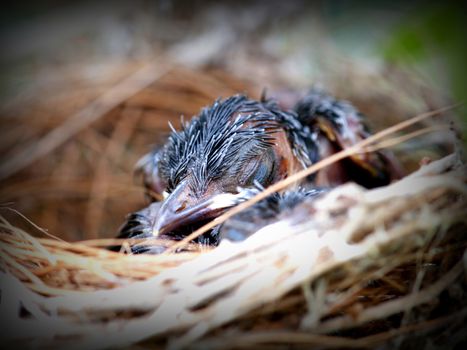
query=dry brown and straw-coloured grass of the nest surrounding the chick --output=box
[0,64,467,349]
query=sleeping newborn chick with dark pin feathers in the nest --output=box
[120,91,400,253]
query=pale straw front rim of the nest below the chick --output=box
[0,66,467,349]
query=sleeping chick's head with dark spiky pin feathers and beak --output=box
[136,96,301,239]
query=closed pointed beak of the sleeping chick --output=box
[153,185,250,236]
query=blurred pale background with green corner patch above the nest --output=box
[0,0,467,131]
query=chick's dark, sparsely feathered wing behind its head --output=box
[295,90,402,187]
